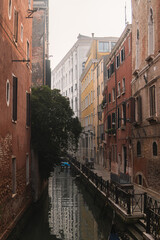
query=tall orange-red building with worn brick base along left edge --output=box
[0,0,32,239]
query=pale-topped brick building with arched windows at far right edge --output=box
[132,0,160,191]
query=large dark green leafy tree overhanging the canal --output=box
[31,86,82,178]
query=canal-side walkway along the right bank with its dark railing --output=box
[71,159,160,240]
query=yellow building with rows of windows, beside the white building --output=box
[80,35,117,165]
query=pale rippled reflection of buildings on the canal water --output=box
[49,168,111,240]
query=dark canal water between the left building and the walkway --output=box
[18,167,131,240]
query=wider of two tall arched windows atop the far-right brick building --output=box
[148,8,154,55]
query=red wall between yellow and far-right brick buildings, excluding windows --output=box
[104,27,132,178]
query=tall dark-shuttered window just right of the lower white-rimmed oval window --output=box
[12,76,18,121]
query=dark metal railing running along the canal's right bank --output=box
[72,157,160,240]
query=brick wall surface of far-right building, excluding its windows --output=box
[132,0,160,193]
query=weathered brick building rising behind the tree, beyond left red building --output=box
[32,0,51,87]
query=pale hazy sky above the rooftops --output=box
[49,0,131,70]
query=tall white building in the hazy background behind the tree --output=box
[51,34,93,118]
